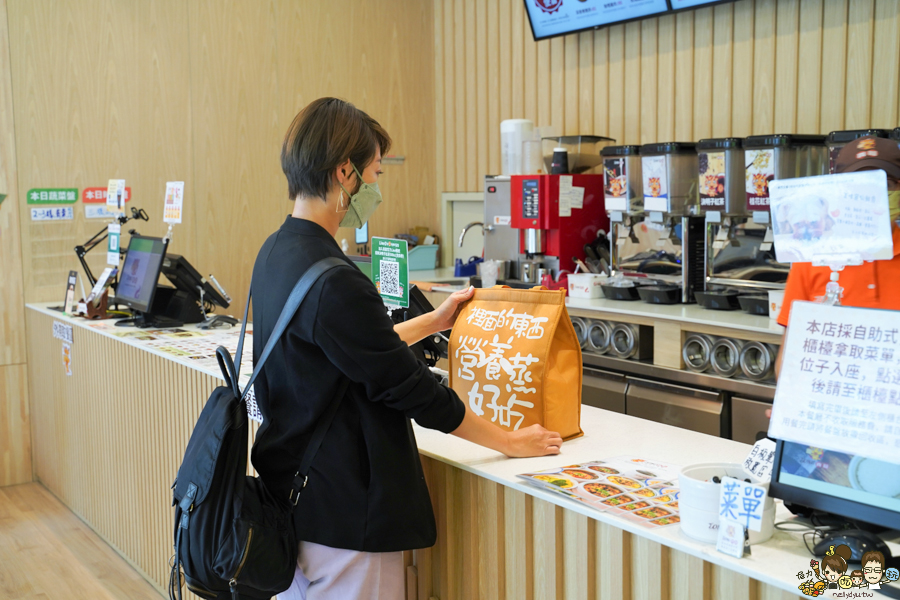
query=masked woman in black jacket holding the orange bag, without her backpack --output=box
[251,98,562,600]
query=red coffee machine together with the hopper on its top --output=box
[510,136,613,284]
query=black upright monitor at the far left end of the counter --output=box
[116,234,166,313]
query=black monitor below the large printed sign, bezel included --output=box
[769,441,900,529]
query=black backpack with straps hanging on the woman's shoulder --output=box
[169,257,349,600]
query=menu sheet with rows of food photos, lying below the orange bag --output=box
[519,456,681,528]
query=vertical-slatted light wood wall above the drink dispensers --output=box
[433,0,900,191]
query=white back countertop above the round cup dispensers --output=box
[566,298,784,335]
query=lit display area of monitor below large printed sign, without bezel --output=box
[778,442,900,517]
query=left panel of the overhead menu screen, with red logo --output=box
[525,0,669,40]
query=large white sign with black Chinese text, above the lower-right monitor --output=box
[769,301,900,463]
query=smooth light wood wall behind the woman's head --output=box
[7,0,436,316]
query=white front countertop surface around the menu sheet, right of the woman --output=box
[414,406,900,594]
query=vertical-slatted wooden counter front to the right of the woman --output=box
[415,457,798,600]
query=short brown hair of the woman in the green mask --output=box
[281,98,391,200]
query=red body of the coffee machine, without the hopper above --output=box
[510,173,609,274]
